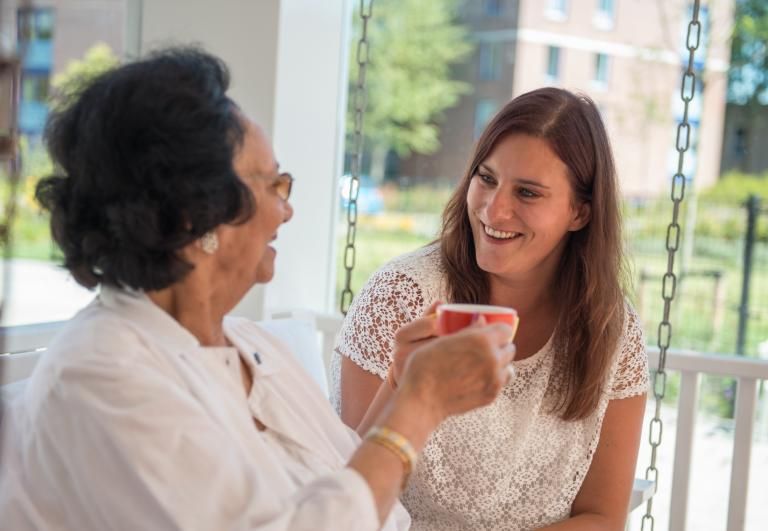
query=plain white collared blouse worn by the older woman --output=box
[0,288,410,531]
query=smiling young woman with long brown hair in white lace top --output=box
[334,88,648,531]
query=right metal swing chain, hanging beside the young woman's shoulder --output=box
[640,0,701,531]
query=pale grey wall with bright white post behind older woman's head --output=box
[140,0,351,318]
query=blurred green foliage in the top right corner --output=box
[729,0,768,105]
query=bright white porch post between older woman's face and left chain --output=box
[266,0,351,311]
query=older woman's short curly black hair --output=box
[36,48,254,290]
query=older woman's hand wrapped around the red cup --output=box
[399,320,515,423]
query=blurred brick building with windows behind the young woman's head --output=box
[401,0,733,198]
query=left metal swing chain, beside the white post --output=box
[341,0,373,315]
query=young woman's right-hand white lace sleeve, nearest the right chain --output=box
[608,304,649,400]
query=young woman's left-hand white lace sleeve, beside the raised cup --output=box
[334,268,431,380]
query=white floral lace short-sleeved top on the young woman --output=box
[331,245,648,531]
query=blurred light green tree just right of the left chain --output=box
[347,0,473,179]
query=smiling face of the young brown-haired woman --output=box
[467,134,589,282]
